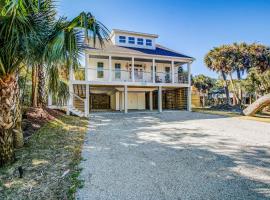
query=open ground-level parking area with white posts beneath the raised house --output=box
[68,84,190,116]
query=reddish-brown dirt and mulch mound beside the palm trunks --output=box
[22,107,64,139]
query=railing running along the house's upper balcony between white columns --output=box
[74,68,188,84]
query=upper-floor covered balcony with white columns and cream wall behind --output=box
[73,56,190,85]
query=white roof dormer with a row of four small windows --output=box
[111,29,158,49]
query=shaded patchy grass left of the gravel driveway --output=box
[0,116,88,200]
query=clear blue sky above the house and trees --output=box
[58,0,270,77]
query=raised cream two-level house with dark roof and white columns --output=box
[56,29,194,116]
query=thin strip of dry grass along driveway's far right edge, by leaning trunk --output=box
[192,108,270,123]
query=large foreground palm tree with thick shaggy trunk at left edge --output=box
[0,0,41,166]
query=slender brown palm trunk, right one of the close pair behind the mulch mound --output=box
[37,64,45,107]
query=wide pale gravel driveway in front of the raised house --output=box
[77,112,270,200]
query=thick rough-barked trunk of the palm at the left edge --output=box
[0,74,20,166]
